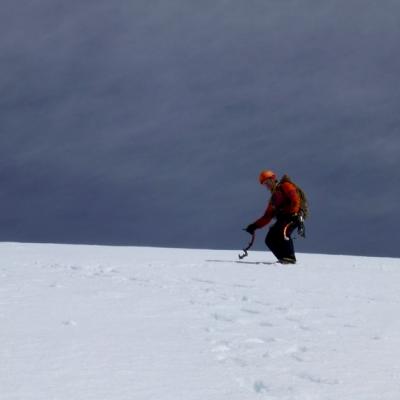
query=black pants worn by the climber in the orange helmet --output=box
[265,216,299,261]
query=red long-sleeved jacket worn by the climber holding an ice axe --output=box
[254,176,301,229]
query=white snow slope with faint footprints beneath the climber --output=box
[0,243,400,400]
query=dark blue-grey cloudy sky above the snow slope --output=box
[0,0,400,257]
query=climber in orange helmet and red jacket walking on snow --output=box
[245,170,301,264]
